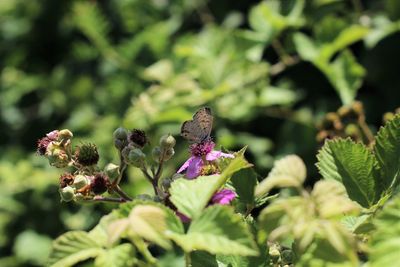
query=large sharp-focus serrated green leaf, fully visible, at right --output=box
[317,139,380,207]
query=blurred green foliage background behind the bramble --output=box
[0,0,400,266]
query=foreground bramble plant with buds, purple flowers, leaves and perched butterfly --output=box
[38,107,400,267]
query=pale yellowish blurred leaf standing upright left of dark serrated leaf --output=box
[255,155,307,196]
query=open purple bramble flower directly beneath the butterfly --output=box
[177,140,234,179]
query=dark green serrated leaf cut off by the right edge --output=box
[374,114,400,190]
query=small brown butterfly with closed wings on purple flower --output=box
[181,107,213,143]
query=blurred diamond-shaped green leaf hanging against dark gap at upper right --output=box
[323,50,365,105]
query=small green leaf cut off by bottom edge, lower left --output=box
[94,243,136,267]
